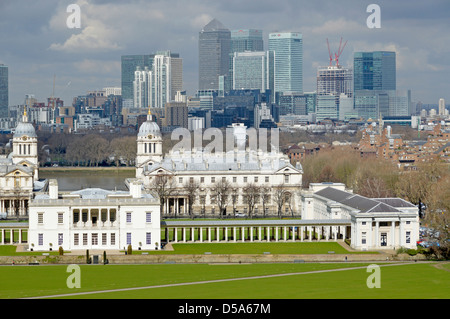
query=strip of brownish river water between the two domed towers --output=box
[39,169,136,191]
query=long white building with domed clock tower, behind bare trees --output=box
[136,115,303,216]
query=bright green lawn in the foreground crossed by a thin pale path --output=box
[0,263,450,299]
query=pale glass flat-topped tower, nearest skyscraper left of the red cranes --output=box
[269,32,303,99]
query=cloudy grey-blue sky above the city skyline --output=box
[0,0,450,106]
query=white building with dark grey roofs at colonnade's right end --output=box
[302,183,419,250]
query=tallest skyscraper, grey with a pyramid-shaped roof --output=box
[198,19,231,90]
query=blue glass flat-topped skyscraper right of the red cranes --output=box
[353,51,396,91]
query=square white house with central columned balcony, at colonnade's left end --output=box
[28,180,161,251]
